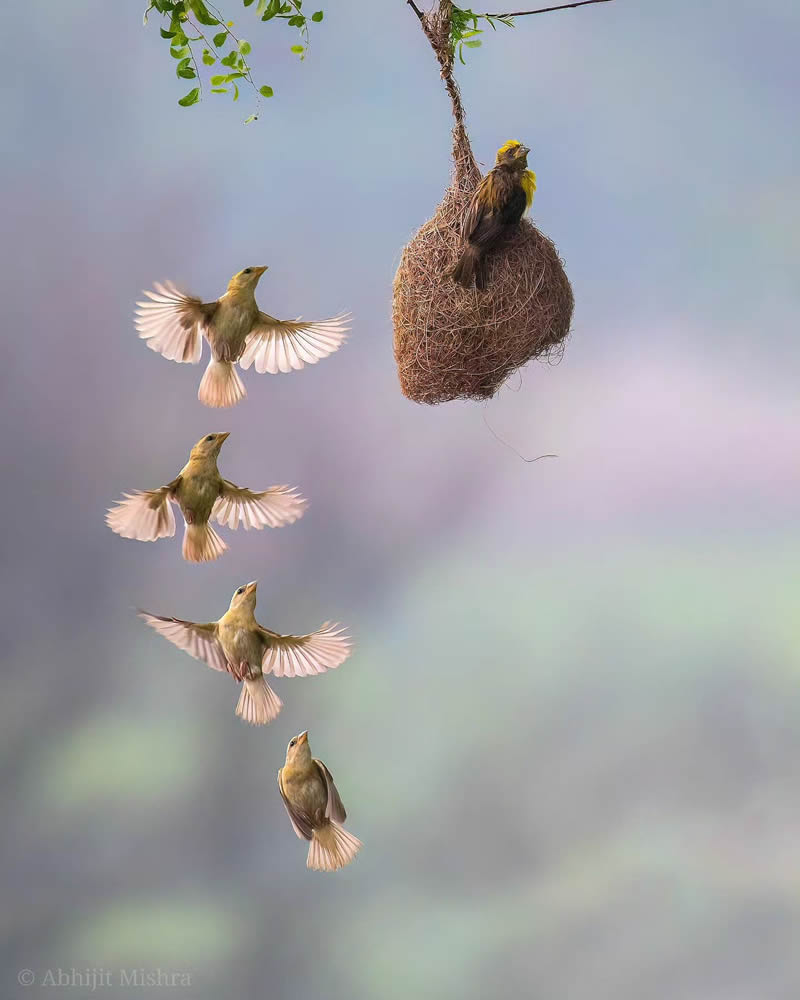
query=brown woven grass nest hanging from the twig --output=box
[392,3,574,403]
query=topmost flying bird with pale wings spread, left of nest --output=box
[135,267,350,407]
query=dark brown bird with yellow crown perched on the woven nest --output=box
[453,139,536,288]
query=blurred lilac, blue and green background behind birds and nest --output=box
[0,0,800,1000]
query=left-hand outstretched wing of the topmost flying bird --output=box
[134,281,217,364]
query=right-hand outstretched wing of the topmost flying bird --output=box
[239,312,350,375]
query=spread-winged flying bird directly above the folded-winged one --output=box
[139,580,351,726]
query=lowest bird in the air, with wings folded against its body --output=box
[278,732,361,872]
